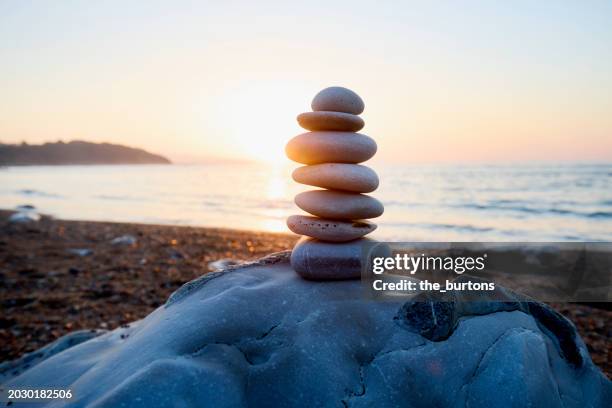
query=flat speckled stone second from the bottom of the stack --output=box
[287,215,376,242]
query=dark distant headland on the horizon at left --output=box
[0,140,171,166]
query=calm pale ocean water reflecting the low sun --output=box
[0,164,612,241]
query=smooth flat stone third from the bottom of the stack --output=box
[295,190,384,220]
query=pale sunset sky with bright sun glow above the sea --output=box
[0,0,612,163]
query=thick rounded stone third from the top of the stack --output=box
[285,131,378,164]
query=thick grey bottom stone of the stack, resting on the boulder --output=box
[290,237,391,281]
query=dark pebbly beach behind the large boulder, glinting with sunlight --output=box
[0,211,612,377]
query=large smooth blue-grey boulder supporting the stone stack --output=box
[0,253,612,407]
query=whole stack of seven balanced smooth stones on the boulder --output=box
[286,87,384,280]
